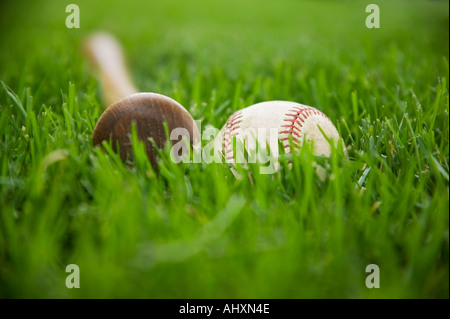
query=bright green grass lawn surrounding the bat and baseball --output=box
[0,0,449,298]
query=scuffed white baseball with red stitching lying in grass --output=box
[214,101,345,162]
